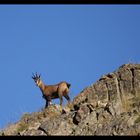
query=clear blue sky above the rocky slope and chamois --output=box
[0,5,140,128]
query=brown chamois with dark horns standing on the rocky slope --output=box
[32,73,71,108]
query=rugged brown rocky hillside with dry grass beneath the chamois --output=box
[0,64,140,136]
